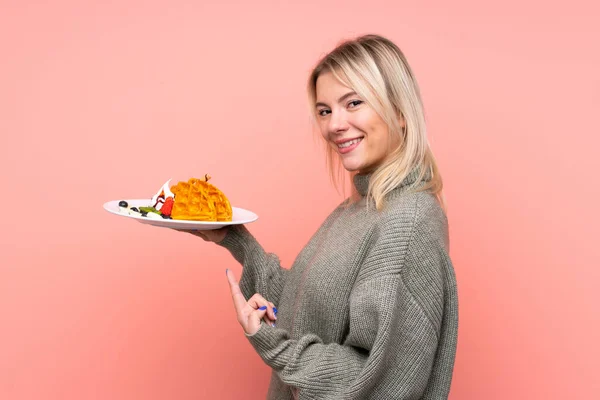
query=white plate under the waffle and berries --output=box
[104,199,258,231]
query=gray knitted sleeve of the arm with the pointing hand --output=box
[248,202,446,400]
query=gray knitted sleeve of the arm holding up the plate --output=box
[219,225,288,304]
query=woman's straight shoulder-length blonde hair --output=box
[308,35,445,210]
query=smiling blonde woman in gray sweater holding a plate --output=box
[195,35,458,400]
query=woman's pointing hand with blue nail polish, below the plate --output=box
[225,270,277,335]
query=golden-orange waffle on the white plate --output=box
[171,177,232,221]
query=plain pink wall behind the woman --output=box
[0,0,600,400]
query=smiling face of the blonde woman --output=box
[316,72,396,173]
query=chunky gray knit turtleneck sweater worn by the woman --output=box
[220,171,458,400]
